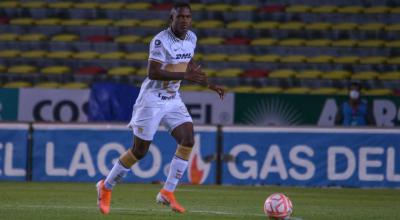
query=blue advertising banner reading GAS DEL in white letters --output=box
[222,127,400,187]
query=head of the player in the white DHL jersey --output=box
[170,2,192,37]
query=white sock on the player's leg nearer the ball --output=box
[163,156,188,192]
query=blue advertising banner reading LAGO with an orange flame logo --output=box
[32,124,216,184]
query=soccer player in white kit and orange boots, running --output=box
[97,3,224,214]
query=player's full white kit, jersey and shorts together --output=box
[129,29,197,141]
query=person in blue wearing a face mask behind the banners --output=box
[335,82,375,126]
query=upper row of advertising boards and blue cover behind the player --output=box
[0,87,400,127]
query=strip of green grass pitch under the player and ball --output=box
[0,182,400,220]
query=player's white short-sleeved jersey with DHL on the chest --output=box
[136,28,197,104]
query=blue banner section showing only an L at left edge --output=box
[0,123,29,181]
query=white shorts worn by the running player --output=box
[129,97,193,141]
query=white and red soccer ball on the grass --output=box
[264,193,293,219]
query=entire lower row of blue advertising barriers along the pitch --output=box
[0,123,400,187]
